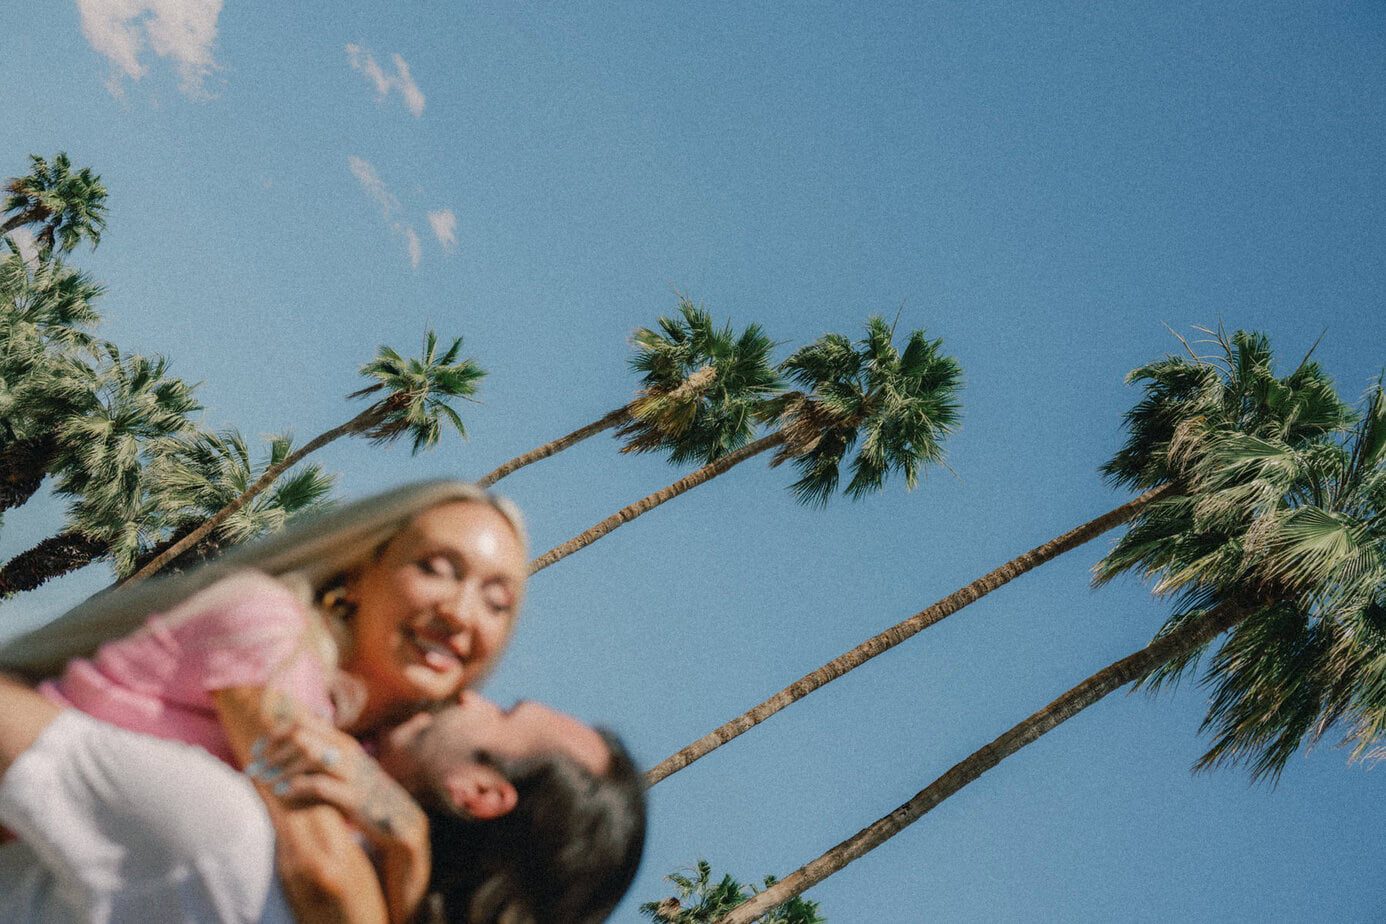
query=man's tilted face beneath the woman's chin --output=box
[380,690,611,779]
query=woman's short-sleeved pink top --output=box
[39,571,333,766]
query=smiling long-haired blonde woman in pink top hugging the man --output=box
[0,482,527,921]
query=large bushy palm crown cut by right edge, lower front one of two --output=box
[1099,385,1386,780]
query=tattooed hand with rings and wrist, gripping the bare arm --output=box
[245,712,428,849]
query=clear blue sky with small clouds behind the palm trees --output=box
[0,0,1386,924]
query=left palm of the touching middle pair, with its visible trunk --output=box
[477,296,778,488]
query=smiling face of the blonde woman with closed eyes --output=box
[342,500,528,718]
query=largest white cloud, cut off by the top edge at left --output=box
[78,0,222,98]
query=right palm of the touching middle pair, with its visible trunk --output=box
[529,317,962,574]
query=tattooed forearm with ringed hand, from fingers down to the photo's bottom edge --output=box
[247,700,430,924]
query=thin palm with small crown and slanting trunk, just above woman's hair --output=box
[125,330,486,585]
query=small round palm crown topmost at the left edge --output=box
[0,152,107,254]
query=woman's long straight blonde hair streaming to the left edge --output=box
[0,481,527,679]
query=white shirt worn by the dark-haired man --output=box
[0,709,292,924]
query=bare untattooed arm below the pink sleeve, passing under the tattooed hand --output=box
[212,687,389,924]
